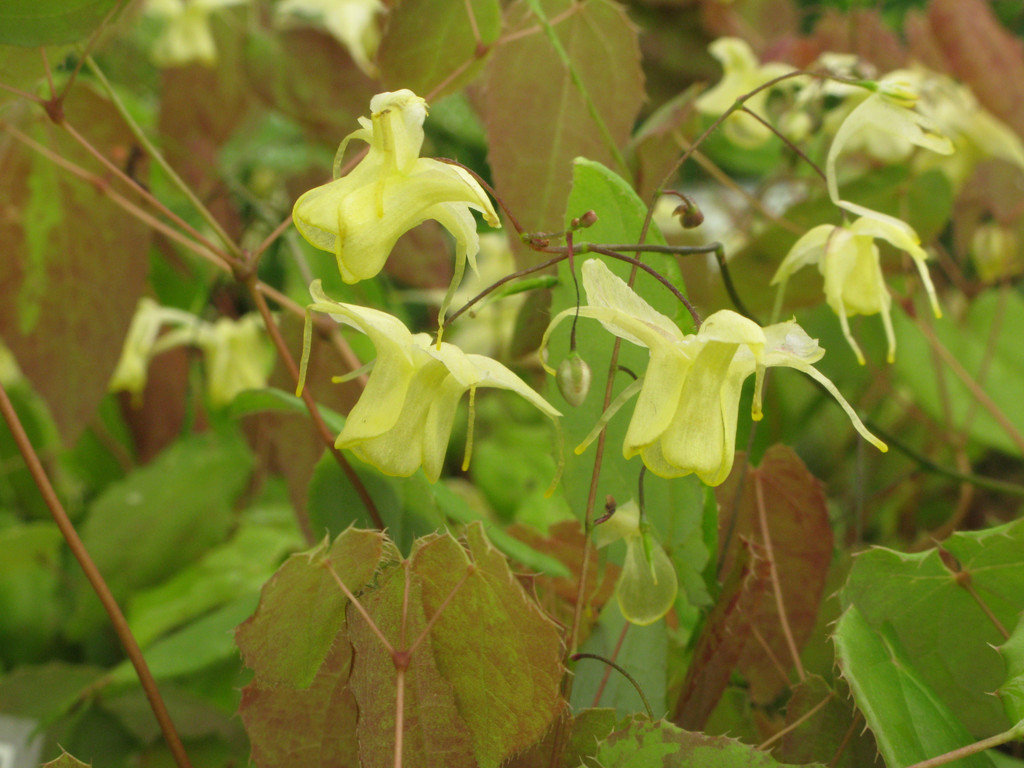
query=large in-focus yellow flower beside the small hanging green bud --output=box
[542,259,886,485]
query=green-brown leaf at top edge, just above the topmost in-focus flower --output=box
[377,0,502,99]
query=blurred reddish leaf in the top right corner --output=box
[928,0,1024,135]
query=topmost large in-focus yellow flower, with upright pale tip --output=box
[292,90,501,315]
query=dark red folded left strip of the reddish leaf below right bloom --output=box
[672,540,771,731]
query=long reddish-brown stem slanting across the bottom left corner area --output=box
[0,383,191,768]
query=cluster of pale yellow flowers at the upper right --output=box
[696,38,966,364]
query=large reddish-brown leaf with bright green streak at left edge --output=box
[0,87,148,444]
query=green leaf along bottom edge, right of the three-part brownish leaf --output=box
[583,716,823,768]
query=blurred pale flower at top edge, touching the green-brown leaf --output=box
[274,0,387,77]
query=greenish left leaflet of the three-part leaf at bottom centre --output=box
[236,528,393,688]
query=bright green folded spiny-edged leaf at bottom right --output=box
[835,597,992,768]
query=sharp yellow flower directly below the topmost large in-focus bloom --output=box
[300,281,561,482]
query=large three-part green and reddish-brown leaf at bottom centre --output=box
[238,523,564,768]
